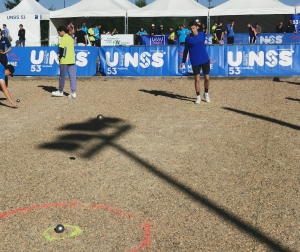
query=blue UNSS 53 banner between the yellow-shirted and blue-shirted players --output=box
[99,46,181,76]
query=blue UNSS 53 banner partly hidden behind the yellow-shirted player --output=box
[7,46,98,76]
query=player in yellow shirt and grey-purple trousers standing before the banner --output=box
[52,26,76,99]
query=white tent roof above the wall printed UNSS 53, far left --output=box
[0,0,50,20]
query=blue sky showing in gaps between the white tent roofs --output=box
[0,0,300,12]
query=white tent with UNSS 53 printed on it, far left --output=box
[0,0,50,46]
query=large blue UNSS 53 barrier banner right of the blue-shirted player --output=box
[224,44,300,77]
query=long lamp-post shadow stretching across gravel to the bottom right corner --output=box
[39,118,292,252]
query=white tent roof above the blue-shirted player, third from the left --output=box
[128,0,208,17]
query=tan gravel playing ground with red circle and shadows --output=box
[0,77,300,252]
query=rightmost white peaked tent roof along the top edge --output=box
[209,0,295,16]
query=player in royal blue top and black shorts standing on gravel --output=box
[180,21,210,104]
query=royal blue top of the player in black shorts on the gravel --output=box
[184,32,209,66]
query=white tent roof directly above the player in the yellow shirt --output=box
[50,0,139,18]
